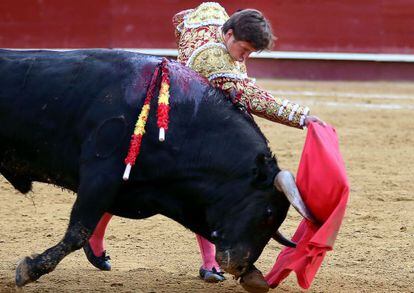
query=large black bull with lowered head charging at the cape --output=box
[0,50,289,286]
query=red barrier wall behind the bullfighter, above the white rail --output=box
[0,0,414,53]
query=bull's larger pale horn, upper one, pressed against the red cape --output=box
[274,170,318,224]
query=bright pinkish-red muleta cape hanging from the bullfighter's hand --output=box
[265,123,349,289]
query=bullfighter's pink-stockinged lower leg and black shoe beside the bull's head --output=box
[196,234,226,283]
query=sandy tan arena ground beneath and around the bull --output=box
[0,80,414,292]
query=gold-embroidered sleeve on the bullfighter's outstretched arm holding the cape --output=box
[210,77,309,128]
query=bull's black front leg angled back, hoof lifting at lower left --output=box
[16,175,120,287]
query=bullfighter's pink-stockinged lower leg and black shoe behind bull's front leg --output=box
[83,213,112,271]
